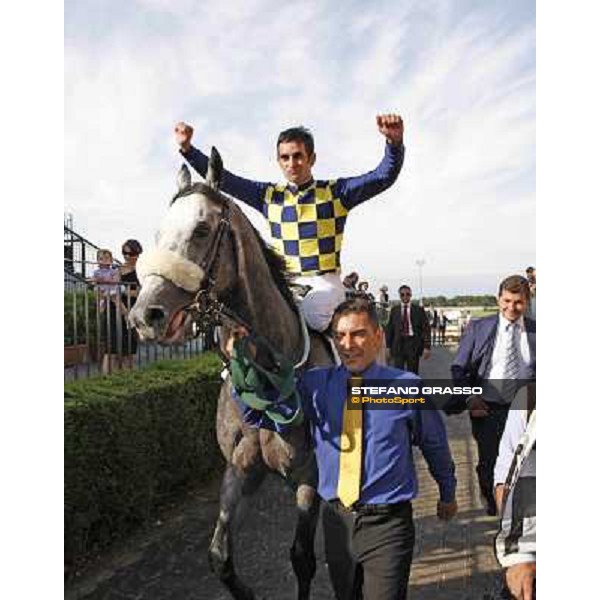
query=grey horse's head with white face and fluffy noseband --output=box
[129,148,235,344]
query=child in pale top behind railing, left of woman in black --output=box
[92,249,127,375]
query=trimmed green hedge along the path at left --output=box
[64,353,222,575]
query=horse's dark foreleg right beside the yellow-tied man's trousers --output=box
[290,484,320,600]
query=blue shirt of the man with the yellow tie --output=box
[234,363,456,504]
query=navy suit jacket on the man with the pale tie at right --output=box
[444,315,536,414]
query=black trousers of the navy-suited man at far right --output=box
[471,402,509,507]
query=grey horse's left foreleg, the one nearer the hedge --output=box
[208,464,264,600]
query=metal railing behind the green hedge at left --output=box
[64,270,214,380]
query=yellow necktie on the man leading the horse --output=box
[337,377,363,508]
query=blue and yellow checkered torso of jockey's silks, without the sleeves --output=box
[263,181,348,275]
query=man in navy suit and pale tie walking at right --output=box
[445,275,535,515]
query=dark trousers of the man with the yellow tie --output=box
[323,502,415,600]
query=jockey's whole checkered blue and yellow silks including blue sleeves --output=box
[182,143,404,275]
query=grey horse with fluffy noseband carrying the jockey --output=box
[130,148,331,600]
